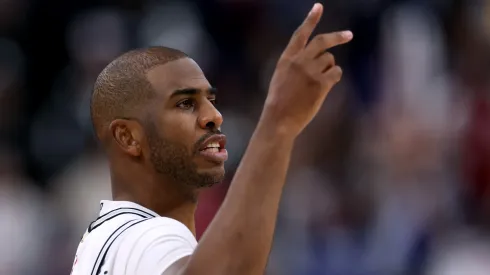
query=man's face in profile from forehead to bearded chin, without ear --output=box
[145,58,228,190]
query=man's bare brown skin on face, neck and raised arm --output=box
[105,4,352,275]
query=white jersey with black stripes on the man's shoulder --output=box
[72,201,197,275]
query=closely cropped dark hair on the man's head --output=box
[90,47,188,139]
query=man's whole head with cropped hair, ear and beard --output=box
[91,47,227,191]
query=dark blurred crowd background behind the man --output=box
[0,0,490,275]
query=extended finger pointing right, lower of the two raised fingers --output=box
[305,31,353,58]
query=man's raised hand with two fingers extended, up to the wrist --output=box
[261,4,352,137]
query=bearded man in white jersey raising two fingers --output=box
[72,4,352,275]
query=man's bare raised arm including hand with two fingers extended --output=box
[164,4,352,275]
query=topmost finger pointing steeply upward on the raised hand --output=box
[283,3,323,56]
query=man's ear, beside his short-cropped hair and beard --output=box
[109,119,143,157]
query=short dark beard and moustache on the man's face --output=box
[146,123,224,189]
